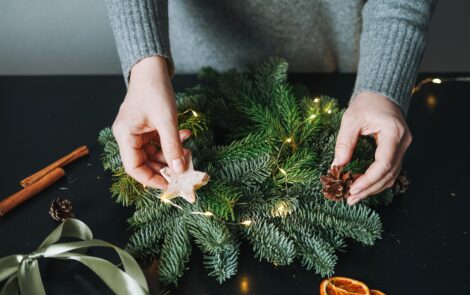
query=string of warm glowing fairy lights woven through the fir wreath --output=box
[150,77,470,227]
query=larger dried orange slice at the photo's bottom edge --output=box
[320,277,370,295]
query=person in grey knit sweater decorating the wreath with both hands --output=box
[106,0,434,205]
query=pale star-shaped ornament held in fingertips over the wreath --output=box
[160,154,209,203]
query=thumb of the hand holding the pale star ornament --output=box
[158,123,187,173]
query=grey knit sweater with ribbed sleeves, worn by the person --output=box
[105,0,434,113]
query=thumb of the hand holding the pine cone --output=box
[332,123,359,166]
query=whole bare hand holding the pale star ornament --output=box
[113,56,191,189]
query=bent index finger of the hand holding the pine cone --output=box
[350,134,400,197]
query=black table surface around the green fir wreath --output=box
[0,74,470,294]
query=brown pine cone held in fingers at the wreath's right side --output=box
[320,166,361,201]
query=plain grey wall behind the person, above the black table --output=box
[0,0,470,75]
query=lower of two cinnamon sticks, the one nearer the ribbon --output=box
[0,168,65,216]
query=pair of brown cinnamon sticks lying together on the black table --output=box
[0,145,90,216]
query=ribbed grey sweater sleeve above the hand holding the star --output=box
[105,0,174,84]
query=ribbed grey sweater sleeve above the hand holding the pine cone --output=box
[352,0,435,114]
